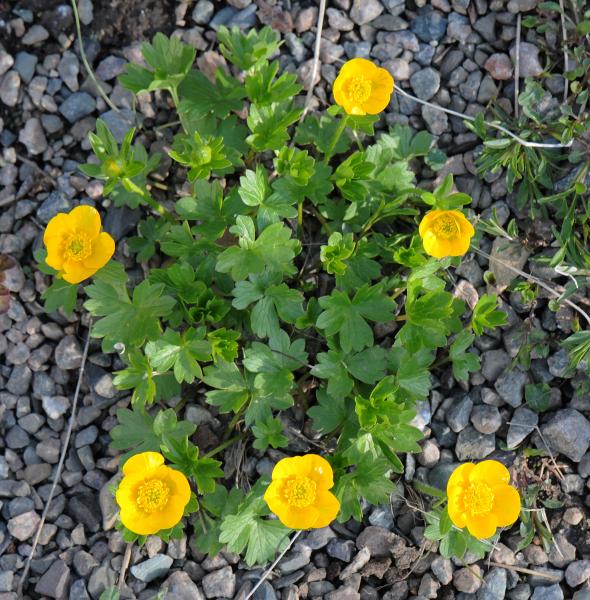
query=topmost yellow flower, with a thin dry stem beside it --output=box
[332,58,393,115]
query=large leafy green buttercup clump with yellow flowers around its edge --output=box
[39,27,528,565]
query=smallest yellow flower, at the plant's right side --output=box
[419,210,475,258]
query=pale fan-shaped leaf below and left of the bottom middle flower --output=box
[219,498,291,566]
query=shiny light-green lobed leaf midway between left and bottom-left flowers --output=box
[145,328,211,383]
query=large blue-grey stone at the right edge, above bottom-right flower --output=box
[541,408,590,462]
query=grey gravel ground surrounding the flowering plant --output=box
[0,0,590,600]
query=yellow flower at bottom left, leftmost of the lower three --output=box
[115,452,191,535]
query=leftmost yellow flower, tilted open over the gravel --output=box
[43,205,115,283]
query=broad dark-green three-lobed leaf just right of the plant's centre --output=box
[316,285,395,352]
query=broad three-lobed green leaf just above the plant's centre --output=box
[216,215,301,281]
